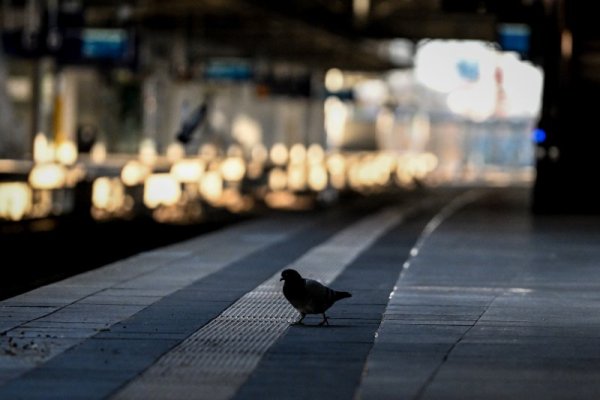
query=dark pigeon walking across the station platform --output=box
[280,269,352,326]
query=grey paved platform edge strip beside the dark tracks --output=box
[0,218,311,388]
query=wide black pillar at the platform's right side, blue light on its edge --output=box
[533,0,600,213]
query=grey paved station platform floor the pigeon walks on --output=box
[0,188,600,400]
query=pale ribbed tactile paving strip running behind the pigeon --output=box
[113,208,412,400]
